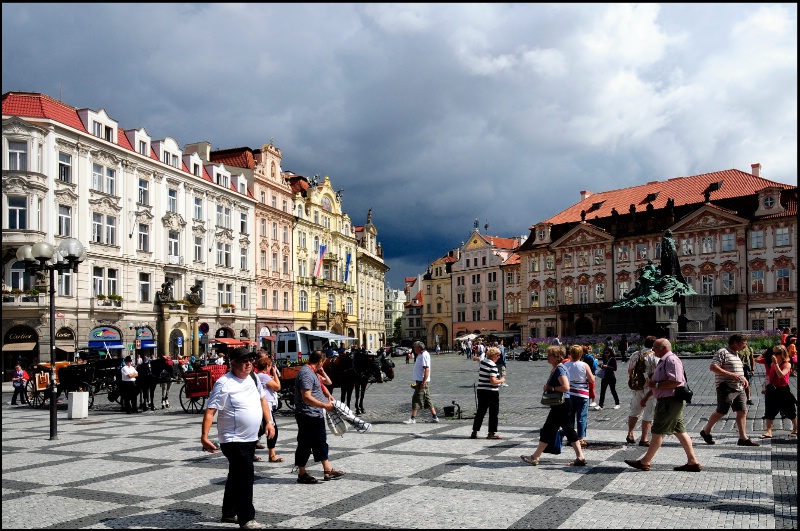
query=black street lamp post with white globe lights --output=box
[17,238,86,441]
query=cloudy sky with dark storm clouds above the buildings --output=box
[2,3,797,288]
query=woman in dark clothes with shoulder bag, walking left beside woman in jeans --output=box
[520,346,586,466]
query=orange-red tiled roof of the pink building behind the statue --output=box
[544,170,792,229]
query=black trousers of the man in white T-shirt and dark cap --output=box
[219,441,256,525]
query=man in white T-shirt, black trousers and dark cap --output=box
[200,347,275,529]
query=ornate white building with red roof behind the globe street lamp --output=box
[2,92,255,380]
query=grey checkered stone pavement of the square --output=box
[2,356,797,529]
